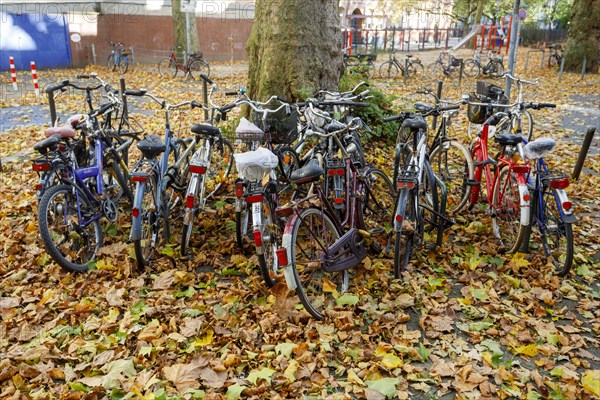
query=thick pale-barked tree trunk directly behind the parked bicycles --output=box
[247,0,342,101]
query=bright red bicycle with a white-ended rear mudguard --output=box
[465,108,531,253]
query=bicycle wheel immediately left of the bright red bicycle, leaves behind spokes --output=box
[429,139,475,215]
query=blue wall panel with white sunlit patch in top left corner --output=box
[0,13,71,71]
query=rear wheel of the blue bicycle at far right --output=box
[539,184,573,276]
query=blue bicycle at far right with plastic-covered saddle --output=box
[520,138,577,276]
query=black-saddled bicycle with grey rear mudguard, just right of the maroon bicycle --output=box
[383,102,459,278]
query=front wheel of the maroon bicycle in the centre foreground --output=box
[358,167,396,255]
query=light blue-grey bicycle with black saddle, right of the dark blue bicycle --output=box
[125,89,204,268]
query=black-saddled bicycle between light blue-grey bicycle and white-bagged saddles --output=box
[181,74,235,256]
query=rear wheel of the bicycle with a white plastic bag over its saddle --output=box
[258,196,281,288]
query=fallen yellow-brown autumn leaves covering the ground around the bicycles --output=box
[0,60,600,400]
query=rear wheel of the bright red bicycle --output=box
[492,165,525,254]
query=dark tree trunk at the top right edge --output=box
[565,0,600,72]
